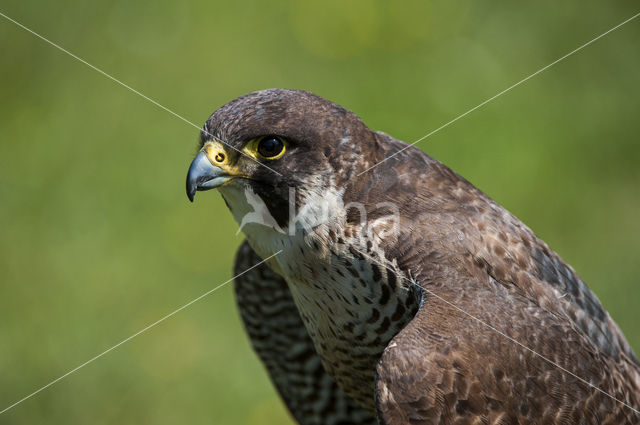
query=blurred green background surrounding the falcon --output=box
[0,0,640,424]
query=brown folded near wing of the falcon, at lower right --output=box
[376,281,640,425]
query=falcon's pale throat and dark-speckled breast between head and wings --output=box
[223,179,418,411]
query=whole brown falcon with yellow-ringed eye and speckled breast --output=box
[187,89,640,425]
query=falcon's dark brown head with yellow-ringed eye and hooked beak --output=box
[186,89,383,233]
